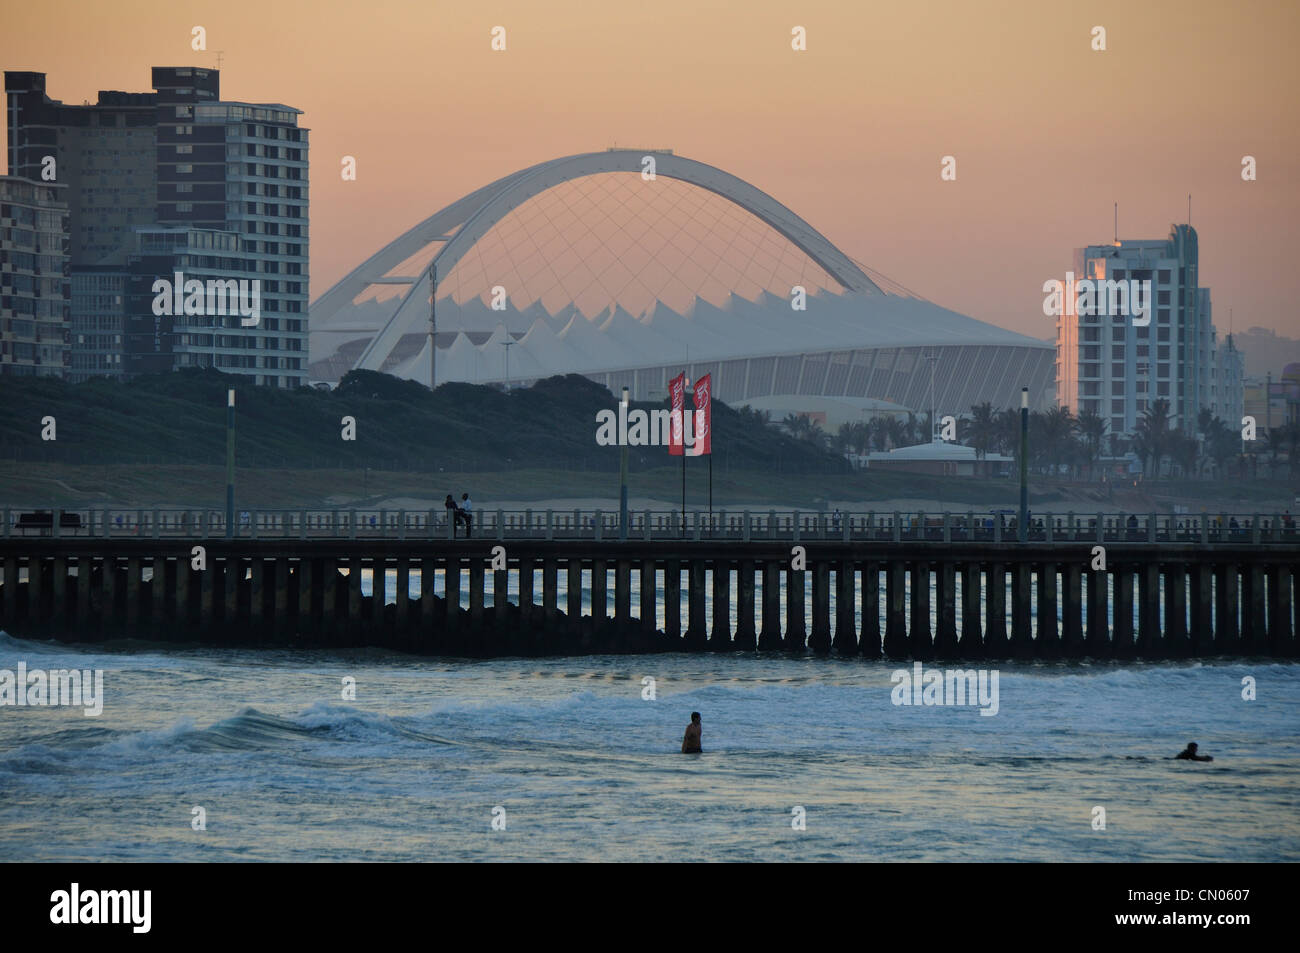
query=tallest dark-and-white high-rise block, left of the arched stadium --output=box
[5,66,309,387]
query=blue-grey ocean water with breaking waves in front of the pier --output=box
[0,634,1300,861]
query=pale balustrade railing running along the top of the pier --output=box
[0,508,1300,545]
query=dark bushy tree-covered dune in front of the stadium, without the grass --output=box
[0,371,849,475]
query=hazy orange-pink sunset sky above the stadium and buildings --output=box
[0,0,1300,338]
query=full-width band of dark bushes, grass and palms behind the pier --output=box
[0,371,1300,512]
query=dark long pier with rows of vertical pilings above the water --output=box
[0,517,1300,660]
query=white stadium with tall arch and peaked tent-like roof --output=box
[311,150,1054,416]
